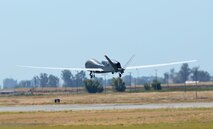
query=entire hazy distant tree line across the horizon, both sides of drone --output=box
[3,64,211,88]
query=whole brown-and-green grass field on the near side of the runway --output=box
[0,108,213,129]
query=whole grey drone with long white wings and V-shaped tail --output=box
[17,55,197,78]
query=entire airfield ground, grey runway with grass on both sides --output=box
[0,91,213,129]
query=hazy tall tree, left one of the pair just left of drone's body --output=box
[61,70,74,87]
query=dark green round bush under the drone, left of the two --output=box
[84,79,104,93]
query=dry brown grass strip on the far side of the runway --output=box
[0,91,213,105]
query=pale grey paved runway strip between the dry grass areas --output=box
[0,102,213,112]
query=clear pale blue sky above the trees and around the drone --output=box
[0,0,213,85]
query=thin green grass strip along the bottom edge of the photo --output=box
[0,121,213,129]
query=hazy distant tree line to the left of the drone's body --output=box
[3,70,86,88]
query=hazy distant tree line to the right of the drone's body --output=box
[123,63,212,85]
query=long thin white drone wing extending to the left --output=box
[16,65,103,72]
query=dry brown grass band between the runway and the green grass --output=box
[0,109,213,125]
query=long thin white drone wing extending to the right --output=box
[126,60,197,69]
